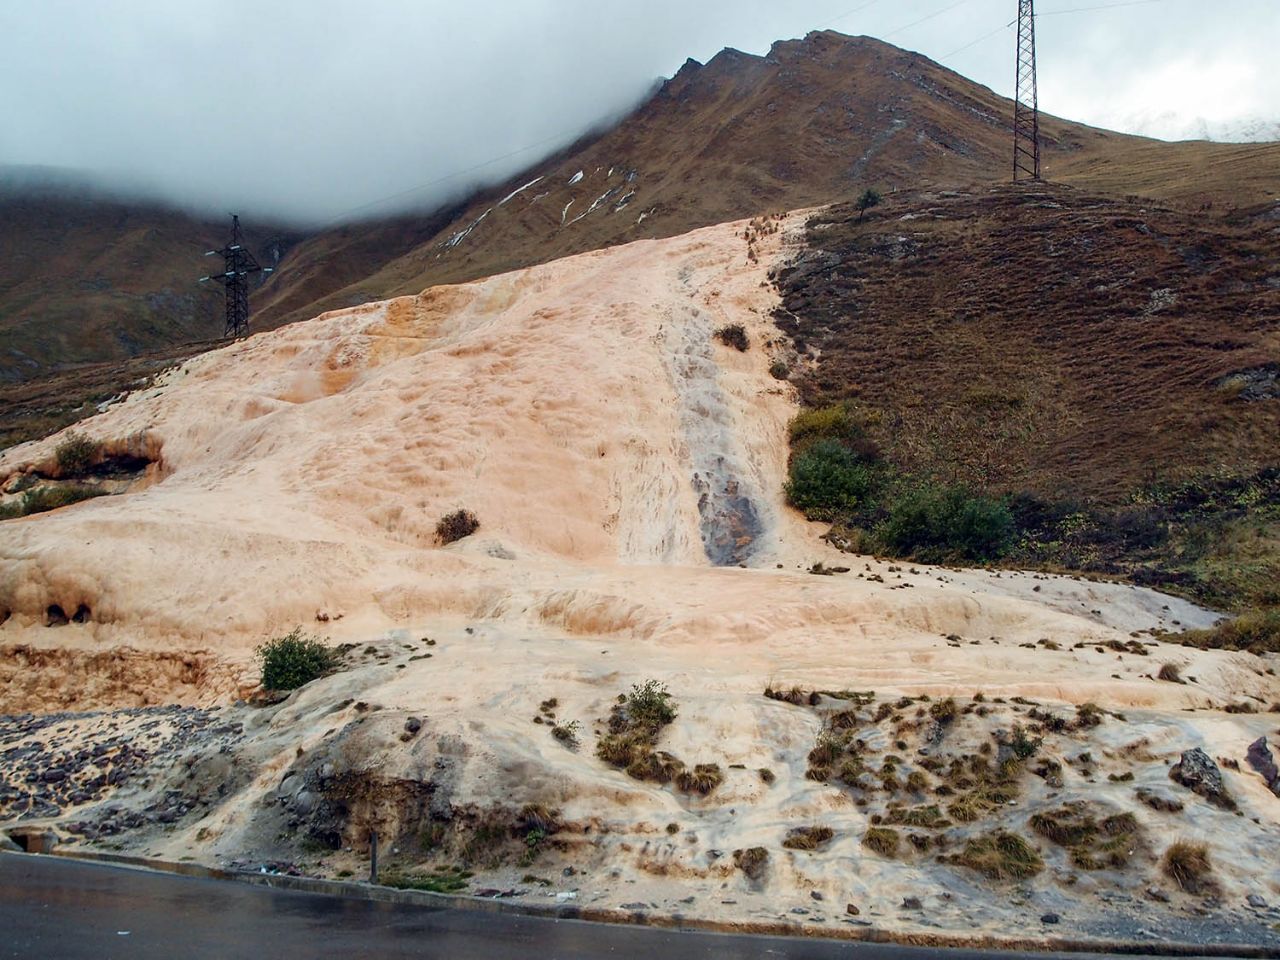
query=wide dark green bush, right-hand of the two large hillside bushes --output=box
[877,484,1015,562]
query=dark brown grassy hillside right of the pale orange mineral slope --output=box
[778,186,1280,604]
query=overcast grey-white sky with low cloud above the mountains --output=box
[0,0,1280,221]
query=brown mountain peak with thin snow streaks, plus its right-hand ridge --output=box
[260,31,1280,324]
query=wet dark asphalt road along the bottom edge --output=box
[0,854,1172,960]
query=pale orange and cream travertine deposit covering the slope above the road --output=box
[0,216,1280,940]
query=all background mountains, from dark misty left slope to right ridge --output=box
[0,32,1280,391]
